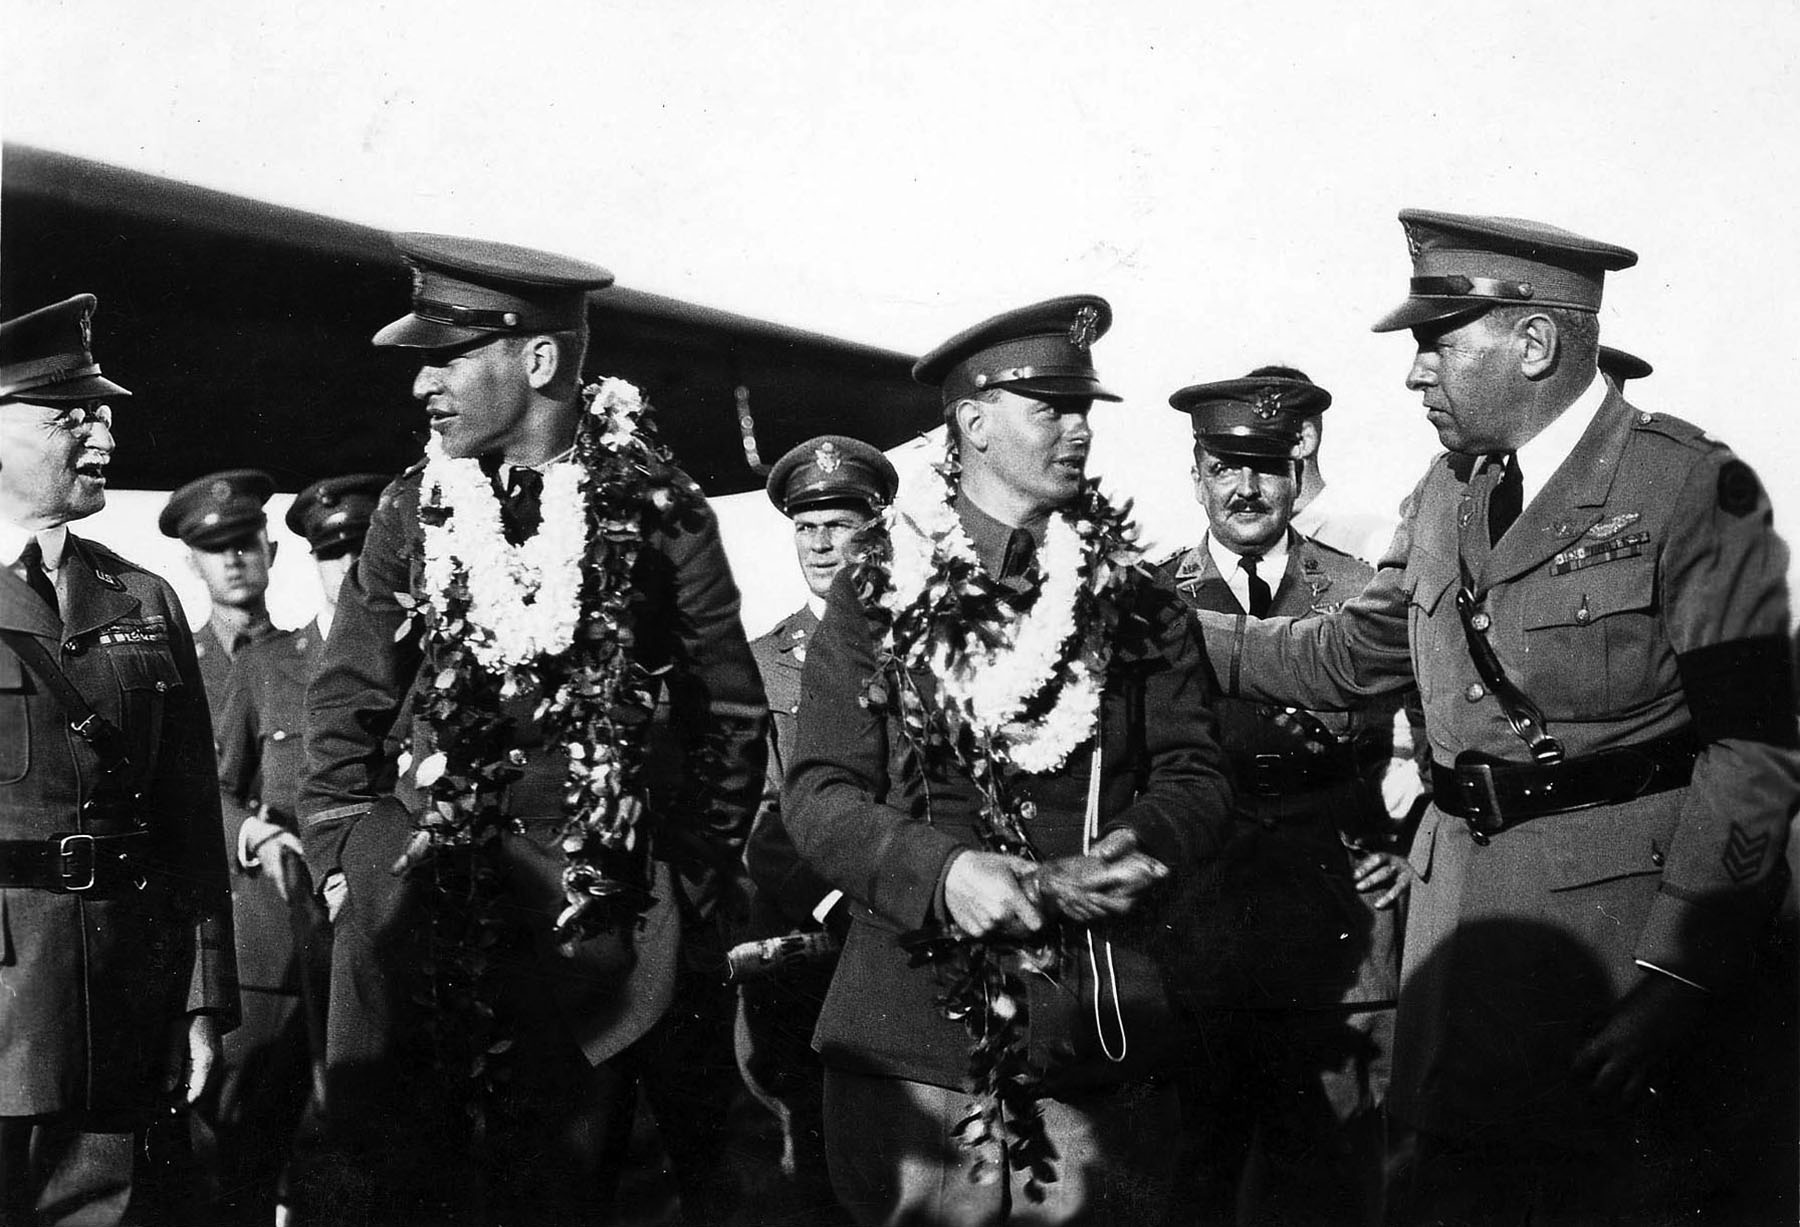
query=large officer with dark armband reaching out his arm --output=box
[1180,209,1800,1222]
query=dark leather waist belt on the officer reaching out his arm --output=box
[1431,729,1699,844]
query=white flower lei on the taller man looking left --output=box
[421,435,589,671]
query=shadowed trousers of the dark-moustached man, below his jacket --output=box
[1170,1006,1393,1227]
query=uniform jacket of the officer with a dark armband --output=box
[1206,389,1800,1144]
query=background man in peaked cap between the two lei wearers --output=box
[743,435,900,1216]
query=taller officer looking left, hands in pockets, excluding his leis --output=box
[299,234,767,1222]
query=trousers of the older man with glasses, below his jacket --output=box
[0,1114,134,1227]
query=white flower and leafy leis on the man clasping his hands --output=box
[855,453,1143,1195]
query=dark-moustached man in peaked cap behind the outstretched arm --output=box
[1163,367,1418,1223]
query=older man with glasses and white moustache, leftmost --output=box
[0,293,238,1227]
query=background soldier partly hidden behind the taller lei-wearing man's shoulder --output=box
[196,473,389,1222]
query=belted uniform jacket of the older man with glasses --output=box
[0,533,238,1130]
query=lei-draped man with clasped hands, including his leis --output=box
[783,295,1229,1223]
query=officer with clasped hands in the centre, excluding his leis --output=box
[783,295,1228,1223]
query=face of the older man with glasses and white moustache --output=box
[0,401,113,529]
